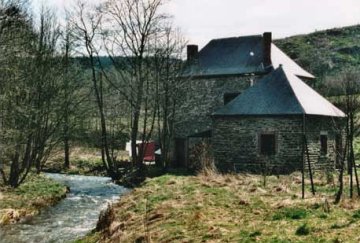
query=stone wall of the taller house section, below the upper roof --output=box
[174,76,258,138]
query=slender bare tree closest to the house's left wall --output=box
[153,24,185,169]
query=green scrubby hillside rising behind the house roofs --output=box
[274,25,360,86]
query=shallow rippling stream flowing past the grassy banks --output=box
[0,174,127,243]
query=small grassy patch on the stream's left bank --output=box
[0,175,67,225]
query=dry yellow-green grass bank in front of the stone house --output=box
[79,171,360,242]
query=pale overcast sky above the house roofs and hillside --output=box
[32,0,360,47]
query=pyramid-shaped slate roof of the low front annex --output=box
[213,66,345,117]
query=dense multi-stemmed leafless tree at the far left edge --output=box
[0,1,60,187]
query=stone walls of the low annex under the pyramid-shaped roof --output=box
[212,116,344,173]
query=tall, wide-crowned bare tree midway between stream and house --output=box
[104,0,167,172]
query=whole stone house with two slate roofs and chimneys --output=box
[174,32,345,173]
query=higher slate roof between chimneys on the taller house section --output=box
[183,35,314,78]
